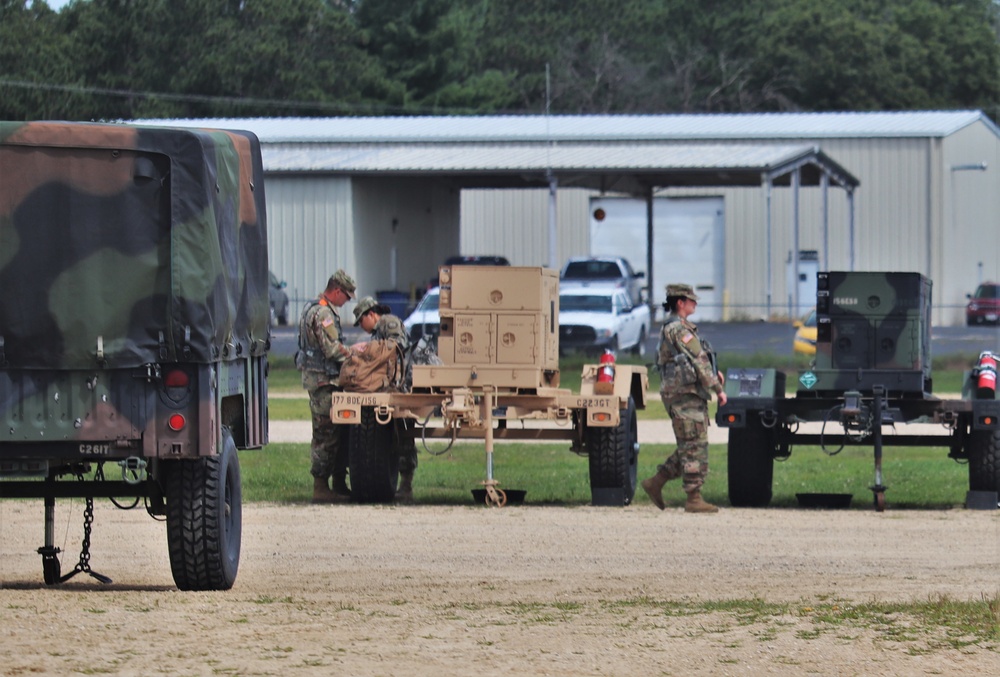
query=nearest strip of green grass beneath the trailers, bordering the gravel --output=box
[240,440,968,510]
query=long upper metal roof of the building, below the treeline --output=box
[136,110,1000,143]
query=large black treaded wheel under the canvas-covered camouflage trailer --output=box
[163,428,243,590]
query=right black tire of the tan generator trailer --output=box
[585,397,639,505]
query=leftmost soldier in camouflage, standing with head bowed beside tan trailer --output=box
[295,270,356,503]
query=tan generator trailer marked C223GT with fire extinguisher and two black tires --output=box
[331,266,648,506]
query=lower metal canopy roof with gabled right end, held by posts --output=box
[262,143,858,193]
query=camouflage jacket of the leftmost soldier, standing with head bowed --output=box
[295,297,351,390]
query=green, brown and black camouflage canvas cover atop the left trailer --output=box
[0,122,270,369]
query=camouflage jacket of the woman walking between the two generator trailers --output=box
[656,314,722,400]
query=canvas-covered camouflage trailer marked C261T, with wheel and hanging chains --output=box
[0,122,270,590]
